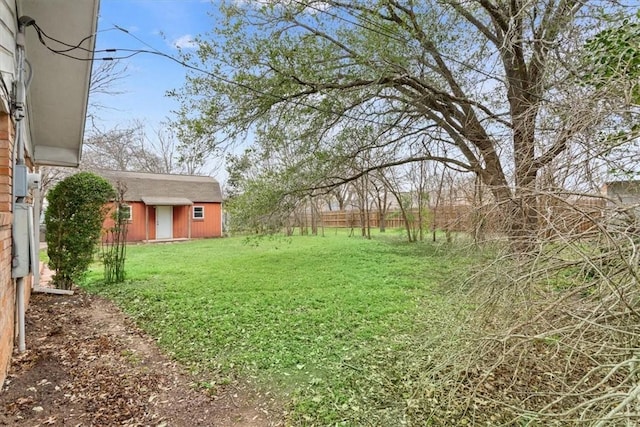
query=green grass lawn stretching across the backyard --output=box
[85,231,473,425]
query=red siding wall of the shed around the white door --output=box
[104,202,222,242]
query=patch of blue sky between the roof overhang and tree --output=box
[89,0,215,128]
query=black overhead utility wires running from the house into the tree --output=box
[31,21,430,130]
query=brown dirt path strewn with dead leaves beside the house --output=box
[0,291,283,427]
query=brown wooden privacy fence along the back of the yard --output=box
[304,198,605,234]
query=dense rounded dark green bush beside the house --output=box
[45,172,115,289]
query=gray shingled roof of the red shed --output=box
[95,170,222,203]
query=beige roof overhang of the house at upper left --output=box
[18,0,99,167]
